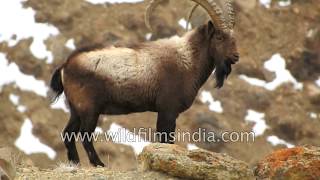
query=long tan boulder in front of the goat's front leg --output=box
[138,143,254,179]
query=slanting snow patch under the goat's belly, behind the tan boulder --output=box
[107,123,150,154]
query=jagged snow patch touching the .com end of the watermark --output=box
[245,109,269,136]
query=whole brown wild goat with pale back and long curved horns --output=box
[50,0,239,166]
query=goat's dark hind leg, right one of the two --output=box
[80,113,104,167]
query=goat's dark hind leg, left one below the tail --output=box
[63,105,80,164]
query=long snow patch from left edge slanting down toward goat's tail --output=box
[0,53,48,97]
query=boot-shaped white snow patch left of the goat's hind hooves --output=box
[15,119,56,159]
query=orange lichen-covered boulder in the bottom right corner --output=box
[255,146,320,180]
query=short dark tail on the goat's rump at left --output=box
[48,67,64,103]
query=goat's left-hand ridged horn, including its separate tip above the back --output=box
[145,0,228,30]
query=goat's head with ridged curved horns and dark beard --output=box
[145,0,239,88]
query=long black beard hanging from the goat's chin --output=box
[214,59,233,88]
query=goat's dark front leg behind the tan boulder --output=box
[157,111,179,144]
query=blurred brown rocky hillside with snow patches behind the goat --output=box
[0,0,320,176]
